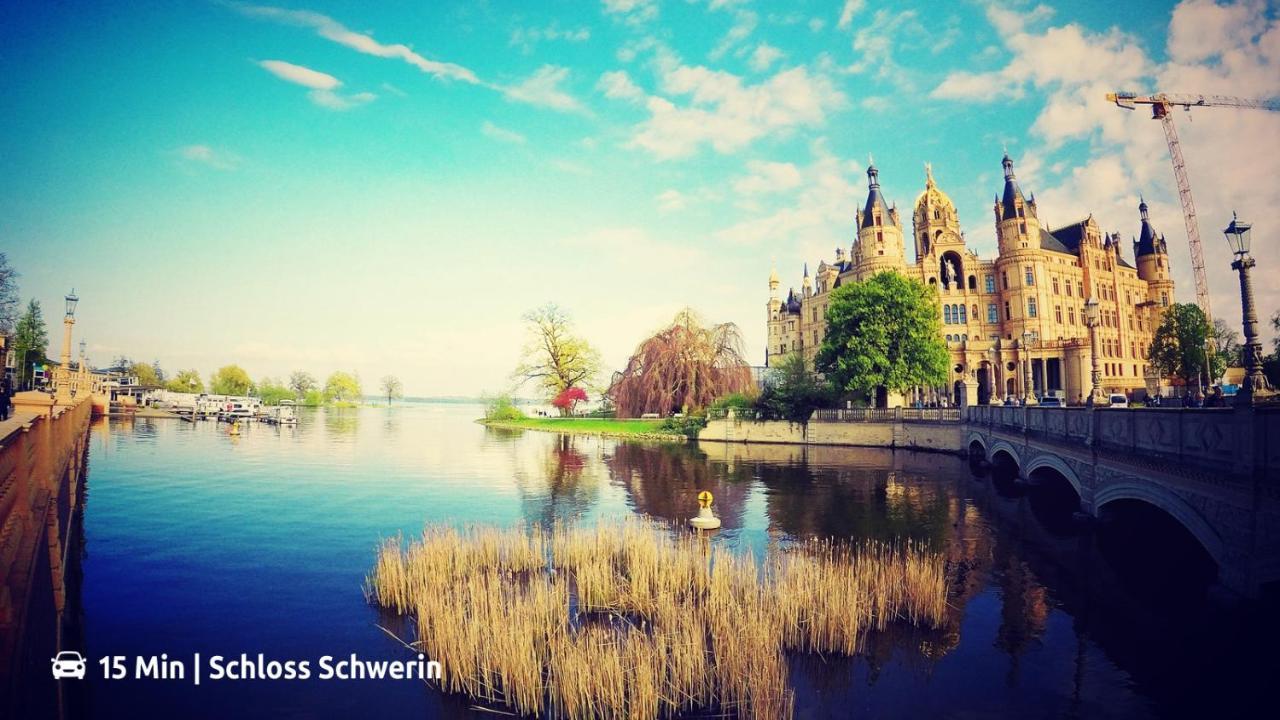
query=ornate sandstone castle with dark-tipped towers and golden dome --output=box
[765,155,1174,405]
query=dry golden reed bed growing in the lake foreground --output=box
[367,518,947,720]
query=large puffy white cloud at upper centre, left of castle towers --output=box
[628,58,846,159]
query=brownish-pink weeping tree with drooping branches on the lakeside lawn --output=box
[608,307,753,418]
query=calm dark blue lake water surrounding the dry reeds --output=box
[73,405,1276,719]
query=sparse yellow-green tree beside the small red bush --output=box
[512,302,600,398]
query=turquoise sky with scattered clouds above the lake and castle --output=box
[0,0,1280,395]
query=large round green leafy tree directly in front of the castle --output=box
[817,272,948,395]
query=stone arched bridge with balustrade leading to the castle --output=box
[964,406,1280,596]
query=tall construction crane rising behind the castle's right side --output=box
[1107,92,1280,327]
